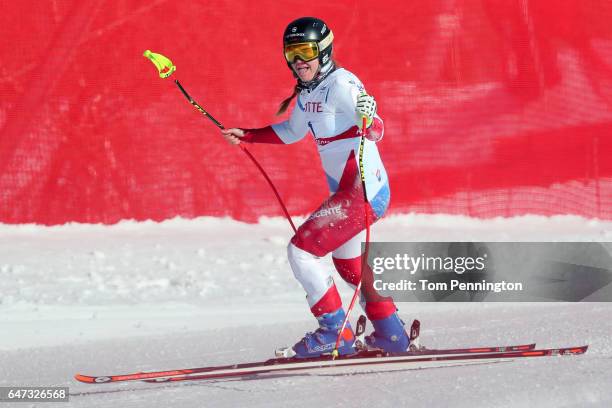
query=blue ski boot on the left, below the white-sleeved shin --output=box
[292,308,356,358]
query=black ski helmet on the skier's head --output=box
[283,17,334,75]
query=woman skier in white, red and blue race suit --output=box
[221,17,410,358]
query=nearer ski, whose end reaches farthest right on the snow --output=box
[143,346,588,383]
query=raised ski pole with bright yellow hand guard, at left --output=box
[143,50,297,233]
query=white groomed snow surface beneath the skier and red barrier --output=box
[0,215,612,408]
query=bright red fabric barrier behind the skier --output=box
[0,0,612,224]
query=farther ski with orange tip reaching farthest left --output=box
[75,343,535,384]
